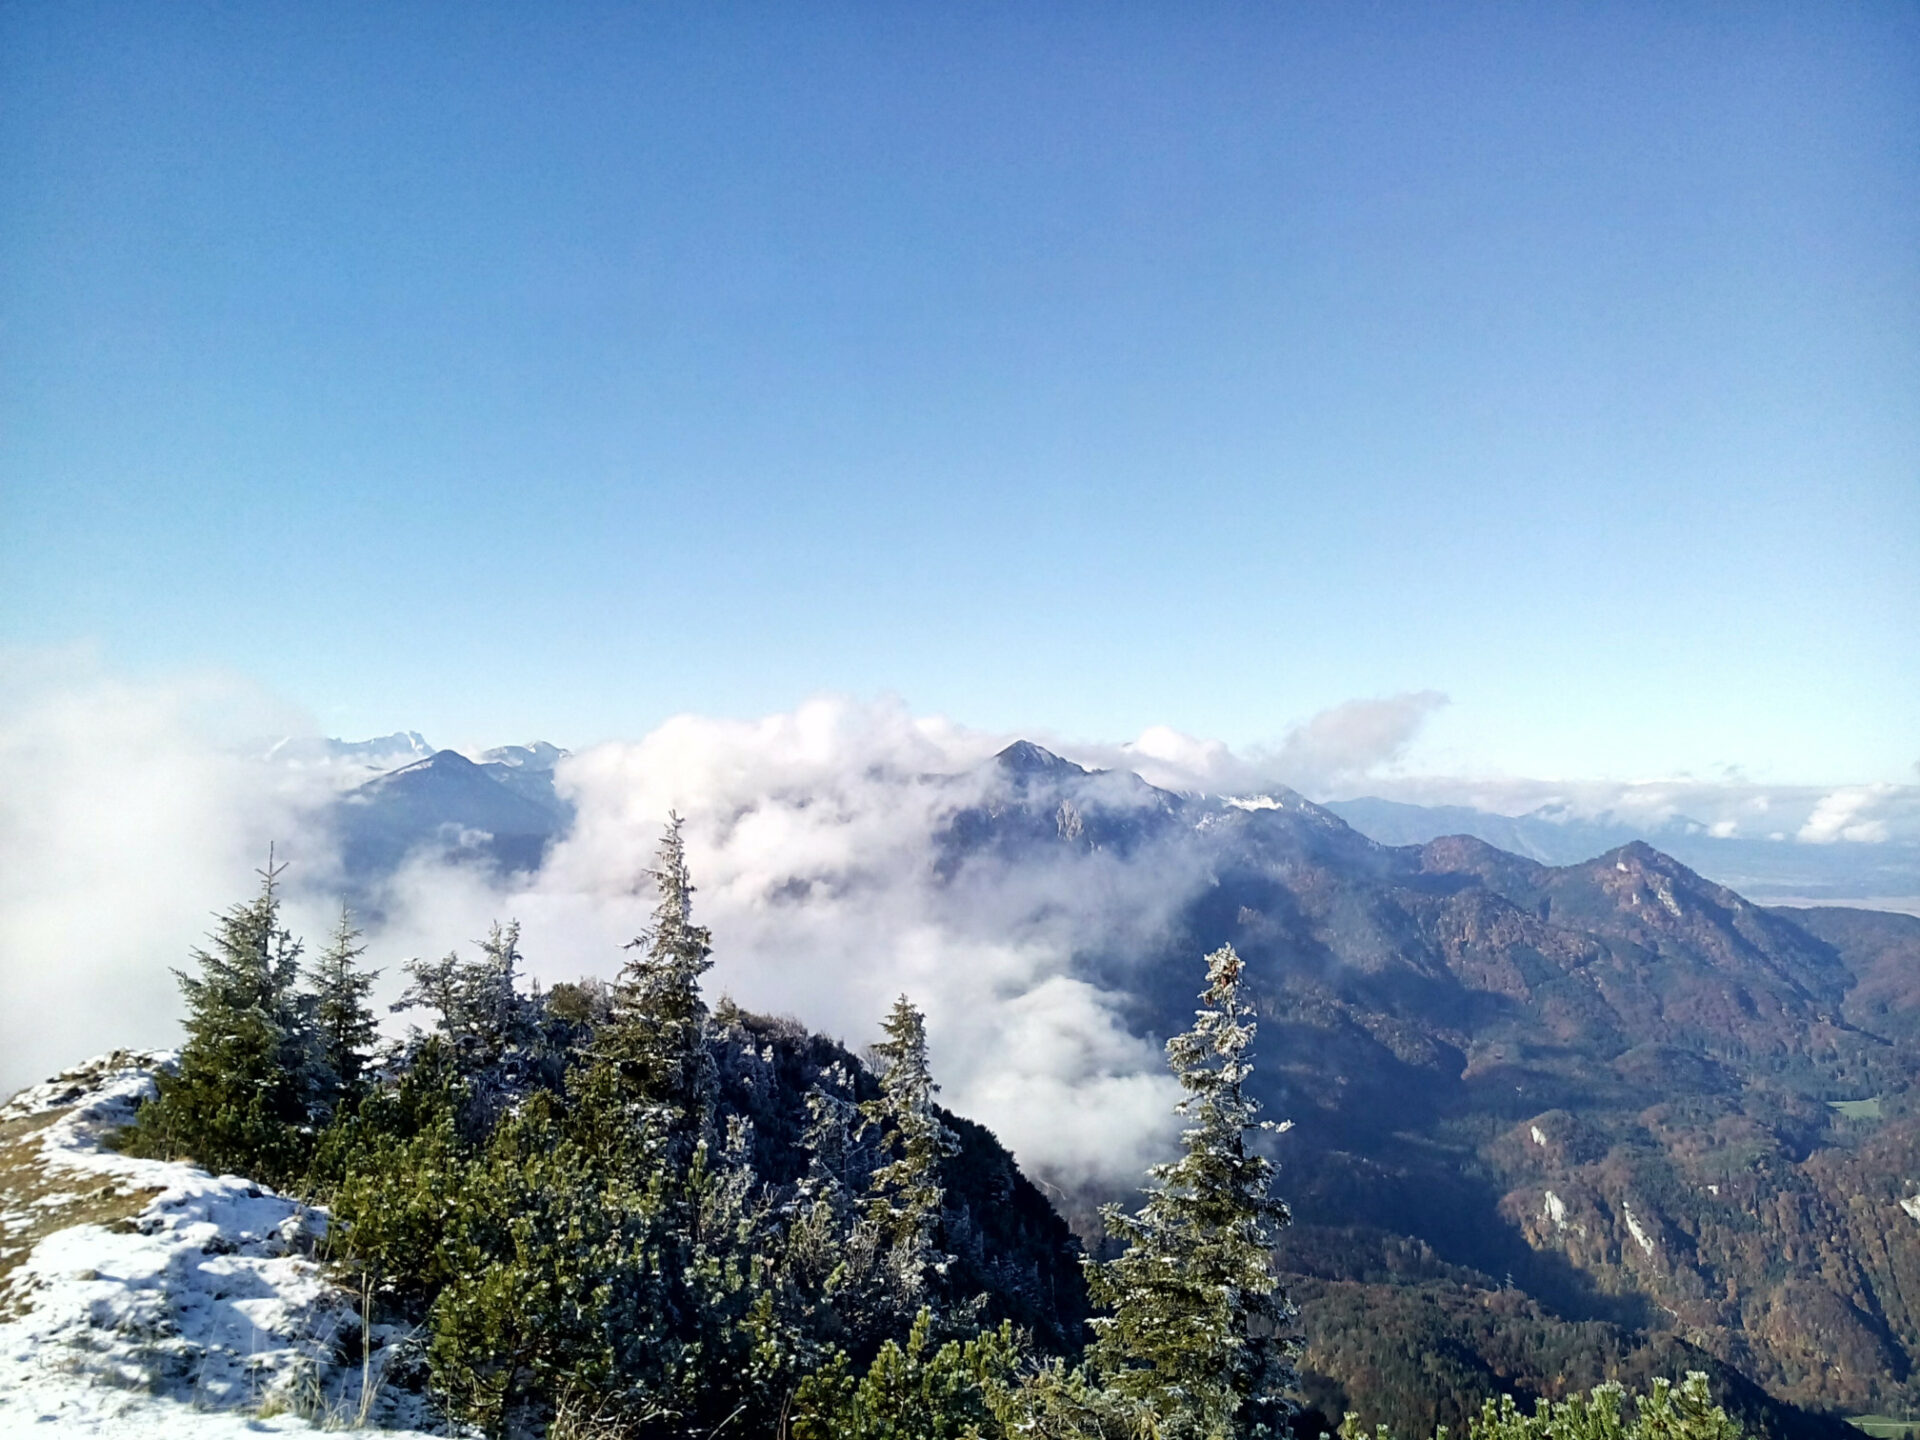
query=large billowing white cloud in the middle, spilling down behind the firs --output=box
[322,699,1200,1185]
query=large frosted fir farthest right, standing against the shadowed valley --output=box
[1087,945,1294,1440]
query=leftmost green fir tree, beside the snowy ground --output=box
[132,851,315,1181]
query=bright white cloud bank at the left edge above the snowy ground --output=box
[0,651,328,1091]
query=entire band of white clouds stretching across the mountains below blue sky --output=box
[0,655,1920,1187]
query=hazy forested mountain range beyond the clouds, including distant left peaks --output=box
[291,743,1920,1434]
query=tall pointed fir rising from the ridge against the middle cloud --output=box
[593,816,716,1142]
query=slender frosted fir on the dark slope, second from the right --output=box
[860,995,960,1277]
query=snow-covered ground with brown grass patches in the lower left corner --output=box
[0,1050,439,1440]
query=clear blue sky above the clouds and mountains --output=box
[0,2,1920,781]
